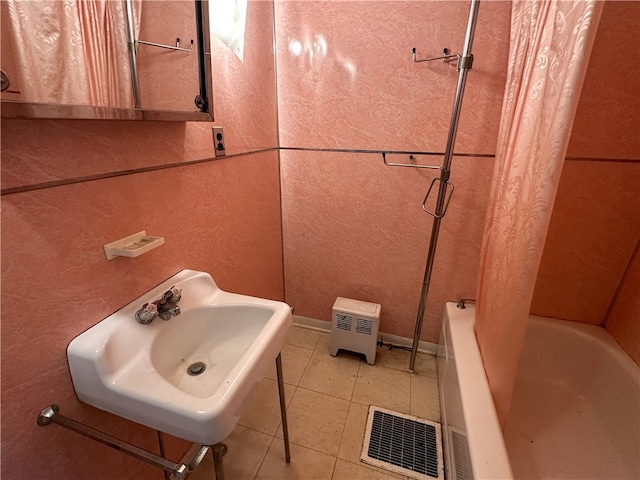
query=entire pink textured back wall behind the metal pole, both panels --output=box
[276,1,510,342]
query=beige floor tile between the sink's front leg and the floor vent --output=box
[276,387,349,455]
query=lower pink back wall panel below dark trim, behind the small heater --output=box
[281,151,493,342]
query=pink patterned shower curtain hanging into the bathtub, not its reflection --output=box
[475,0,603,428]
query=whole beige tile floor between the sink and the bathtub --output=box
[189,326,440,480]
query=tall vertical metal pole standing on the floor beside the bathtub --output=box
[409,0,480,373]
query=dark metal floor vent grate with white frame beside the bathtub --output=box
[360,406,444,480]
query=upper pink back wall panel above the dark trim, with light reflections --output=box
[276,1,509,153]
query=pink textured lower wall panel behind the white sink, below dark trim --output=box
[2,151,284,478]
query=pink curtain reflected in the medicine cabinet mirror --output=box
[3,0,139,108]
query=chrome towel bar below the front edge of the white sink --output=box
[38,405,189,479]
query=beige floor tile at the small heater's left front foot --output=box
[299,351,360,400]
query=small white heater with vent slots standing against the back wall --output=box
[329,297,381,365]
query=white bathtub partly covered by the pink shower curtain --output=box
[438,303,640,480]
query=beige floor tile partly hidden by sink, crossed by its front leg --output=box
[238,378,296,436]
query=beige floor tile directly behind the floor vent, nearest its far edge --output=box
[351,363,411,413]
